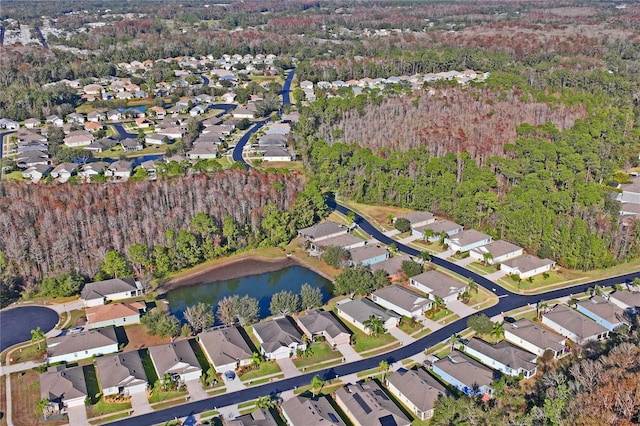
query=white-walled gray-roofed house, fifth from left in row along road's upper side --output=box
[253,317,307,359]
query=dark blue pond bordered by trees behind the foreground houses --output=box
[166,265,333,320]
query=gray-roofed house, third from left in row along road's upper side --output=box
[149,340,202,382]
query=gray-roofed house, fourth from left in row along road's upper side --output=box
[198,327,253,372]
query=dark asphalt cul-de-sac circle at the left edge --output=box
[0,306,58,352]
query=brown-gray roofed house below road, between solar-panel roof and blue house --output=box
[388,368,447,411]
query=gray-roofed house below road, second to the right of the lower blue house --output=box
[503,318,569,358]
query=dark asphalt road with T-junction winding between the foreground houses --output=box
[112,202,640,426]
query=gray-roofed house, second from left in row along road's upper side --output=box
[96,351,148,389]
